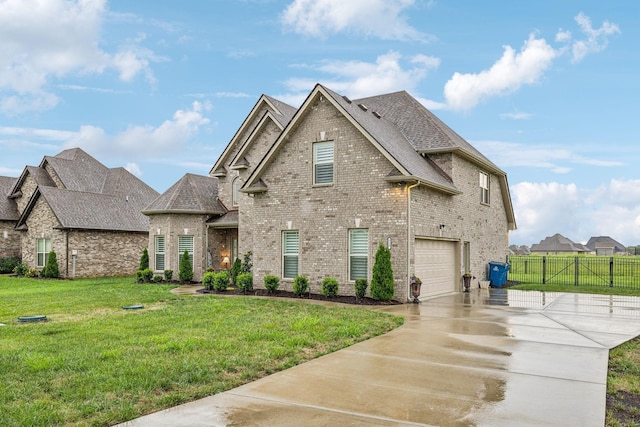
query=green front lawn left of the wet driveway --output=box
[0,276,403,426]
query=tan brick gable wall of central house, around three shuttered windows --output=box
[239,93,407,300]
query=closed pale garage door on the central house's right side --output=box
[415,239,458,296]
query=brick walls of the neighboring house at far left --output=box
[22,197,149,277]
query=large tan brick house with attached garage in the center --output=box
[144,85,515,302]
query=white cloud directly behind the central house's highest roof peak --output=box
[278,51,440,105]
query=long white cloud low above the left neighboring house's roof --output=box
[63,102,210,157]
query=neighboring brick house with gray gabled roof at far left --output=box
[8,148,158,277]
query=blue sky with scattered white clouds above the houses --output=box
[0,0,640,245]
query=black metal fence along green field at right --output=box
[508,255,640,288]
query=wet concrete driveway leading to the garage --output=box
[117,289,640,427]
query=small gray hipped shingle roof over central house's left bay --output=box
[143,173,226,215]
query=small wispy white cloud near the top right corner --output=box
[556,12,621,62]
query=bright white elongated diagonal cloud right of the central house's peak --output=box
[444,34,557,110]
